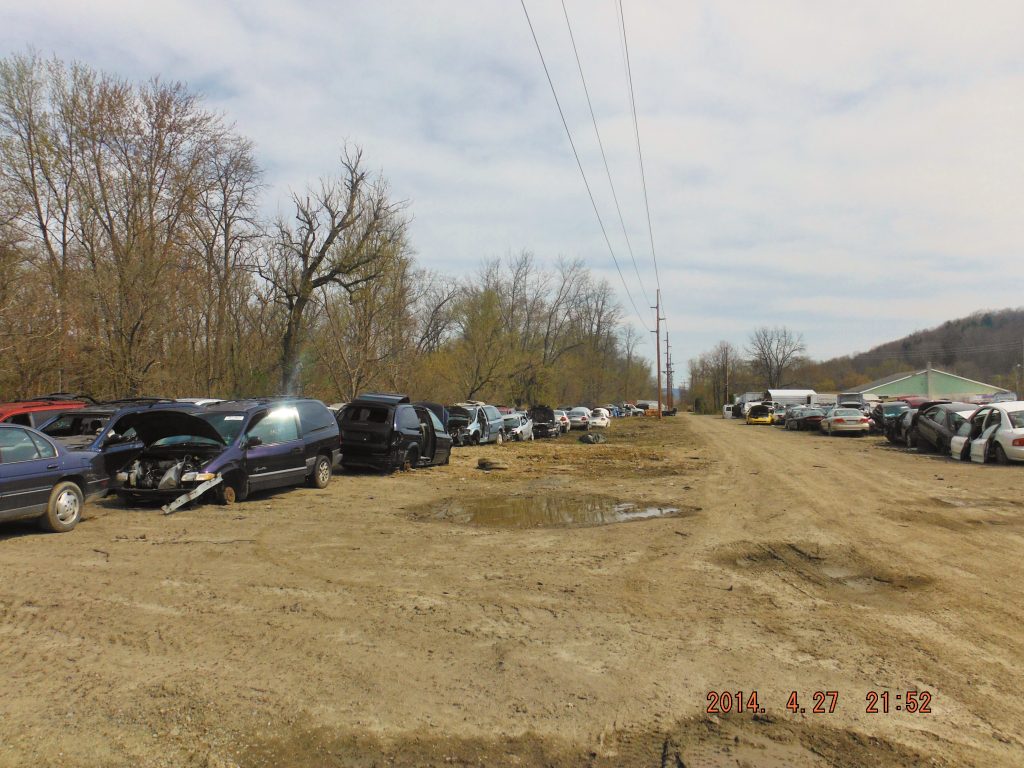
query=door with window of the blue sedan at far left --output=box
[0,428,60,517]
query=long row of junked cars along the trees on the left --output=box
[0,393,638,531]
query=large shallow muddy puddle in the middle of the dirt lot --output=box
[416,496,694,528]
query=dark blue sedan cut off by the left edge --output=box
[0,424,108,532]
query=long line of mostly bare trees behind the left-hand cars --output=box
[0,52,654,403]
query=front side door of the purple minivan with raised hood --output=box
[242,406,306,490]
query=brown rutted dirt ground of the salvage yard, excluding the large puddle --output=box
[0,416,1024,768]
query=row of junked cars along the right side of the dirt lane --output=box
[746,396,1024,464]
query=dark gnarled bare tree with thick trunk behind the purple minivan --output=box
[257,147,406,392]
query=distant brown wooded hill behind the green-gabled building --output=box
[802,308,1024,391]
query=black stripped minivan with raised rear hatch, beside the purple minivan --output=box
[338,393,452,472]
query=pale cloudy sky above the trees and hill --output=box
[0,0,1024,372]
